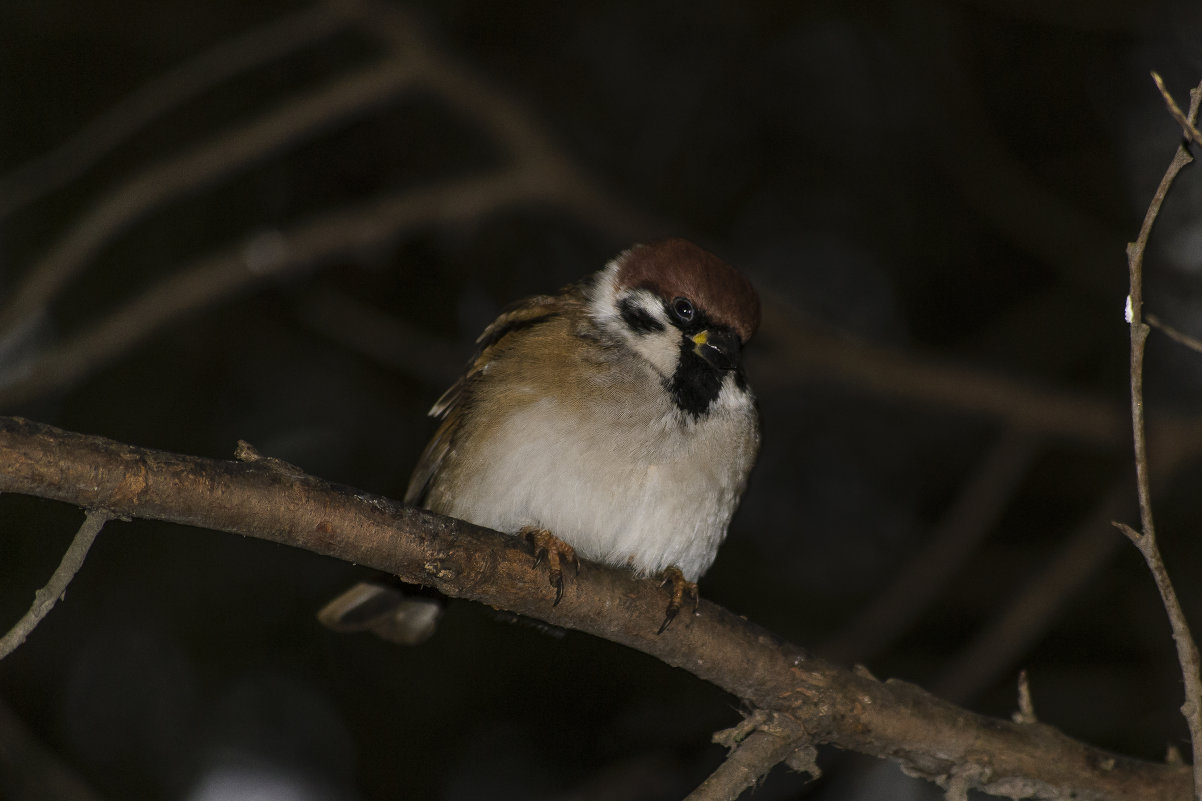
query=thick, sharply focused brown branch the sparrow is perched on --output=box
[0,417,1189,800]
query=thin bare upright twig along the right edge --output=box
[1115,73,1202,801]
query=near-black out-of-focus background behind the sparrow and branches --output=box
[0,0,1202,801]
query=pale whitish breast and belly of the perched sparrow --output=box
[428,368,758,581]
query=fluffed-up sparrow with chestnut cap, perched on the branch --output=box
[319,238,760,643]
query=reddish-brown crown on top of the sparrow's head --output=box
[618,234,760,343]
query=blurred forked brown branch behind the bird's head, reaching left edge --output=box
[0,0,664,407]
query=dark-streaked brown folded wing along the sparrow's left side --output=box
[405,293,579,506]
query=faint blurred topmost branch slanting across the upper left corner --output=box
[0,5,340,218]
